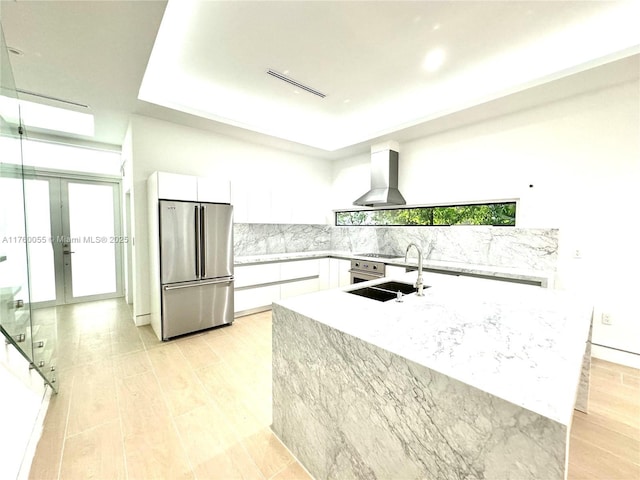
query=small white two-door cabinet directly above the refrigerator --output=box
[149,172,231,203]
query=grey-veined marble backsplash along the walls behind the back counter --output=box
[234,223,558,271]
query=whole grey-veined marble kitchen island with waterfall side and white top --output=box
[272,272,592,480]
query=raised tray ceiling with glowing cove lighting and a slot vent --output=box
[140,1,640,150]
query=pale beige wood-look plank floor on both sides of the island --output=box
[30,299,640,480]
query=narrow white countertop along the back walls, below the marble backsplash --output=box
[234,250,555,287]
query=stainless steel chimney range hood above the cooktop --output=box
[353,142,407,207]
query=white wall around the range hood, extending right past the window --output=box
[332,81,640,361]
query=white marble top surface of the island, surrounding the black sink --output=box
[278,272,592,425]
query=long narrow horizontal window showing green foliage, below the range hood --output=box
[336,202,516,226]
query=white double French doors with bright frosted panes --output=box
[25,175,127,306]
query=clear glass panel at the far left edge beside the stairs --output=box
[0,21,57,391]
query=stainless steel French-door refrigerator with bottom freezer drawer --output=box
[159,200,233,340]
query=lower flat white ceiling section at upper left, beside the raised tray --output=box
[0,0,166,145]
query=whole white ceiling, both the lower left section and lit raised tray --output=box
[0,0,640,158]
